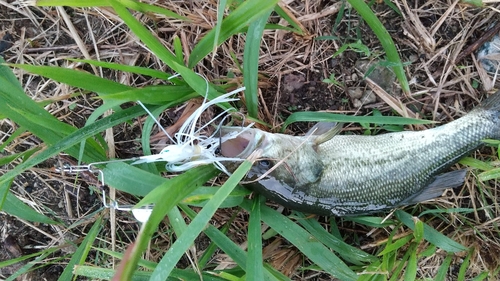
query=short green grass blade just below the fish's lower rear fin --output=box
[394,210,467,253]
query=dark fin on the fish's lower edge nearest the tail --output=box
[399,169,467,206]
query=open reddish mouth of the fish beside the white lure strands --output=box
[220,127,261,158]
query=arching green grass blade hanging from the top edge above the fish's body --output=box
[347,0,410,93]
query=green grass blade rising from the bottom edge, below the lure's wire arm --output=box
[57,217,102,281]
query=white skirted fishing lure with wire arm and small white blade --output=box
[56,76,253,223]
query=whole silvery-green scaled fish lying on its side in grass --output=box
[220,91,500,216]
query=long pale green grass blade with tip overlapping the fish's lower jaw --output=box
[147,160,252,280]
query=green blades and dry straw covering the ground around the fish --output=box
[0,0,500,280]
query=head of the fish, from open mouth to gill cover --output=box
[220,127,323,186]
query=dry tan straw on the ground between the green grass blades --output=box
[0,0,500,280]
